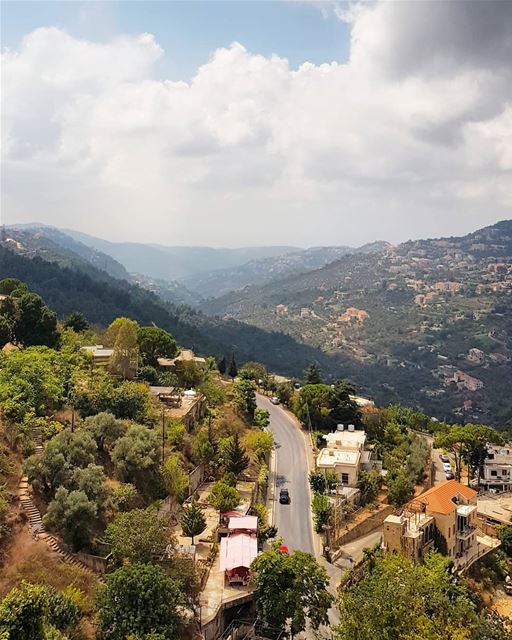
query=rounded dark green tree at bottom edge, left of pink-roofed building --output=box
[97,564,184,640]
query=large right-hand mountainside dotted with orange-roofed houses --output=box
[201,220,512,423]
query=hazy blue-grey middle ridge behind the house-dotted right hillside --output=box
[183,242,390,298]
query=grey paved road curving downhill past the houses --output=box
[257,394,315,555]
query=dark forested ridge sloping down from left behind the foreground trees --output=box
[0,231,348,375]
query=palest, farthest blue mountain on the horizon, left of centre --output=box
[62,229,298,281]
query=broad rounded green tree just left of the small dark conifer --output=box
[105,507,175,564]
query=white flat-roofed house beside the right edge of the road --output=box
[316,425,371,487]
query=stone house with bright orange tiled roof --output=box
[383,480,499,569]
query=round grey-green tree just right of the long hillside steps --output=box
[43,487,98,549]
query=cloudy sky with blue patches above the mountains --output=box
[1,0,512,246]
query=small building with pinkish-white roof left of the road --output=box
[219,514,258,585]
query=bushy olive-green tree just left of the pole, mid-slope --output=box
[112,424,160,490]
